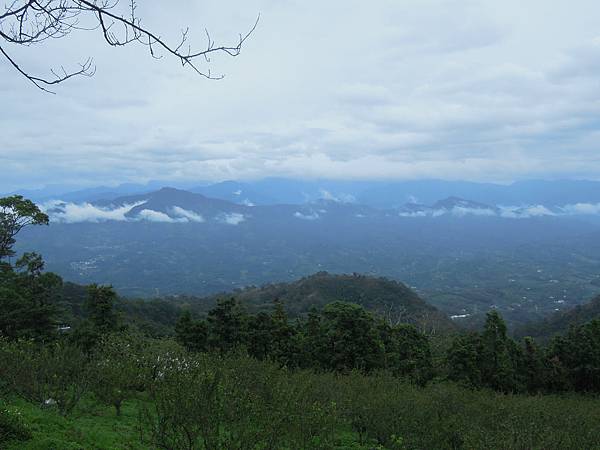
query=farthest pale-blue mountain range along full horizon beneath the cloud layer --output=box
[9,178,600,209]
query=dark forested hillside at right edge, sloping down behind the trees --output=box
[515,296,600,342]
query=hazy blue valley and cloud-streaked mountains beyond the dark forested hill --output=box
[19,185,600,323]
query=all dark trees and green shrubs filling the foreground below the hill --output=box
[0,194,600,450]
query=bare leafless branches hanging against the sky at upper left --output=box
[0,0,258,92]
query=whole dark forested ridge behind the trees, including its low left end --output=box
[61,272,455,334]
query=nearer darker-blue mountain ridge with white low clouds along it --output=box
[36,187,600,225]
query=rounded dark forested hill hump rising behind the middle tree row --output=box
[202,272,455,331]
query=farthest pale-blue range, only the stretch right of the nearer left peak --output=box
[190,178,600,208]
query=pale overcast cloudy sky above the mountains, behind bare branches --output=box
[0,0,600,192]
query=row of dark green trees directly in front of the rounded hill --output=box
[176,299,433,384]
